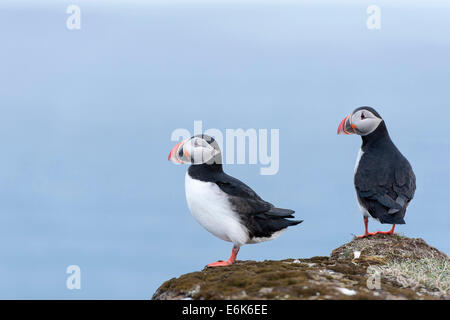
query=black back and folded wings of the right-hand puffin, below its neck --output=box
[355,149,416,224]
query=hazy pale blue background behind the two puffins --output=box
[0,0,450,299]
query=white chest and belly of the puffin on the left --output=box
[185,173,248,246]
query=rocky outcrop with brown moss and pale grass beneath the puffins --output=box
[153,235,450,300]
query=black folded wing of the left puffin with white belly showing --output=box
[214,173,302,238]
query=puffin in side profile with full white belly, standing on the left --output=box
[169,134,302,267]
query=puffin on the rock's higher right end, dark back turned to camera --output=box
[337,106,416,238]
